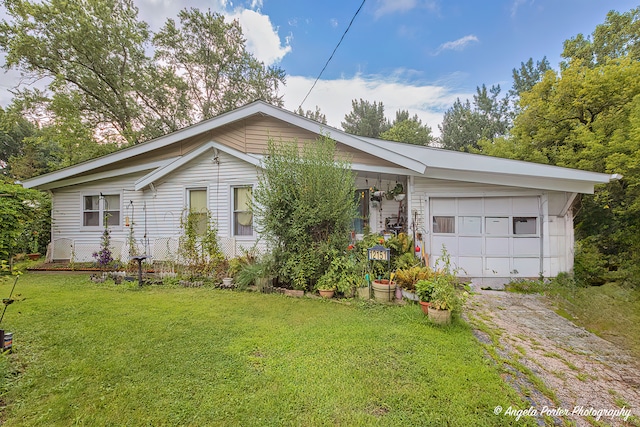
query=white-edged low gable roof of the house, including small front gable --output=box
[23,101,616,193]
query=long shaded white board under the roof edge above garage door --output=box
[424,168,595,194]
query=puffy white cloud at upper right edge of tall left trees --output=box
[230,9,291,65]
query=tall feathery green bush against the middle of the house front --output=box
[252,137,356,289]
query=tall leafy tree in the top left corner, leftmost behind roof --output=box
[0,0,150,142]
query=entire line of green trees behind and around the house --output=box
[0,0,640,287]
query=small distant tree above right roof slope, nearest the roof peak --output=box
[341,99,391,138]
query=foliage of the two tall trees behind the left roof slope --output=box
[0,0,284,147]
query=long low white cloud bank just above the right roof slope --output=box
[283,74,472,135]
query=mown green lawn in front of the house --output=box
[0,274,534,426]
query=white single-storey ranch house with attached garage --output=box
[23,101,618,283]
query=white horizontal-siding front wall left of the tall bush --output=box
[50,150,264,262]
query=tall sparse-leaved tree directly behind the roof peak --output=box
[153,8,284,122]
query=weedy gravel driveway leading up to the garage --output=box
[467,290,640,426]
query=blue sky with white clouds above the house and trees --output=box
[0,0,638,134]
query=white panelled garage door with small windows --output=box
[426,197,541,277]
